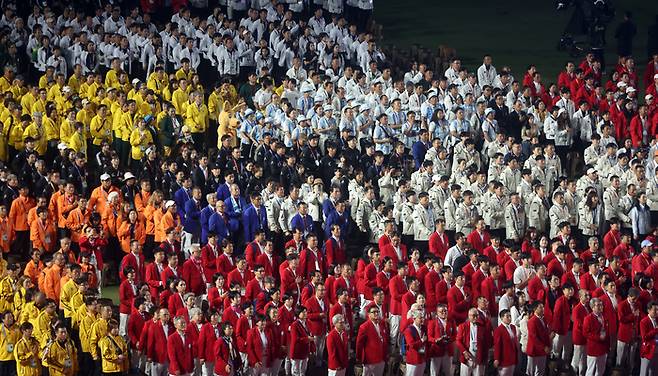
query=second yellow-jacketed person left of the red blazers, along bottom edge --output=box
[42,324,78,376]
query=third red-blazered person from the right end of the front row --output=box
[583,298,610,376]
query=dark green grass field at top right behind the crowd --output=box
[374,0,658,89]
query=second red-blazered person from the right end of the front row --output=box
[615,287,640,367]
